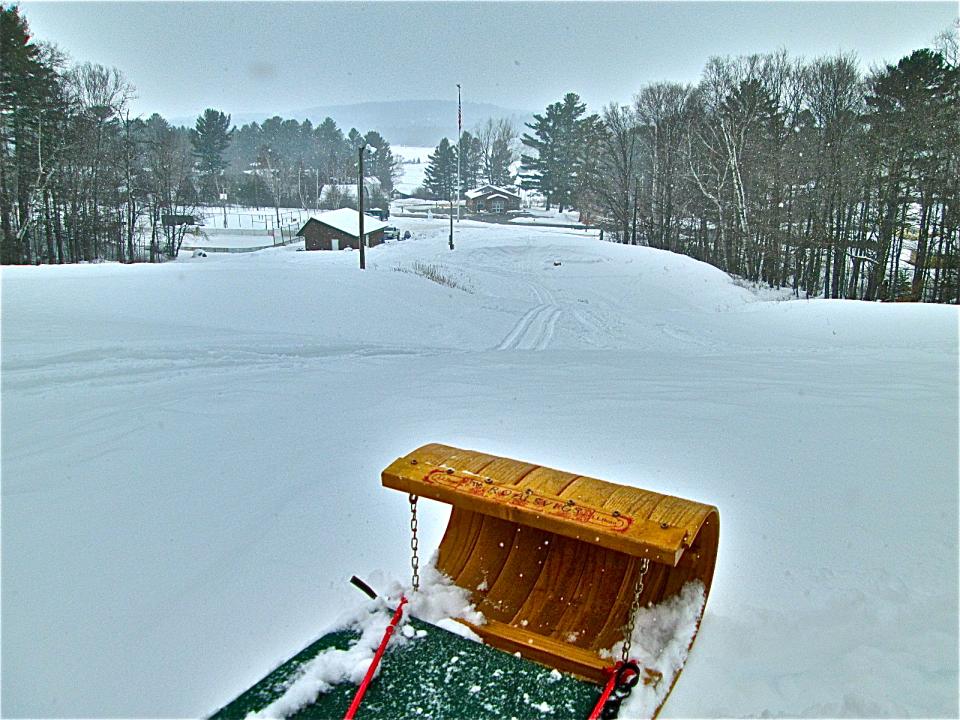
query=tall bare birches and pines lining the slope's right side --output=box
[521,35,960,303]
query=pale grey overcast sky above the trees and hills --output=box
[21,1,957,117]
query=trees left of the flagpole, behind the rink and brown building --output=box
[0,6,399,264]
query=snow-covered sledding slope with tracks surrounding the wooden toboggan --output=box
[2,219,960,717]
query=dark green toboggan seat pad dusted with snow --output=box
[211,617,601,720]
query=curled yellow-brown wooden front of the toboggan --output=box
[382,444,720,715]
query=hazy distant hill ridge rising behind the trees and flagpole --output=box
[170,100,533,147]
